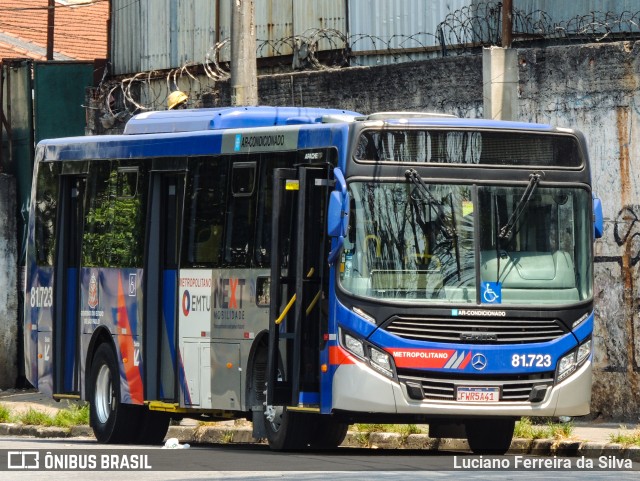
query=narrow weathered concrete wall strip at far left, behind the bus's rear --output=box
[0,174,18,389]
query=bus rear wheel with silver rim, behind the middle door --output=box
[88,343,139,444]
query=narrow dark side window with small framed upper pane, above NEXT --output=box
[224,162,256,267]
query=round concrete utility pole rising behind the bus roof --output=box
[231,0,258,106]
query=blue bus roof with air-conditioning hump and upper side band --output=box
[33,106,581,161]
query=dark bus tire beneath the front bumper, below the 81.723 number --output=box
[465,418,516,455]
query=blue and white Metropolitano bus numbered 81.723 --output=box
[24,107,602,452]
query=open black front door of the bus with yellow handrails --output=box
[267,165,330,407]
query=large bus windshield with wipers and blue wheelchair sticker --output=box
[340,181,592,305]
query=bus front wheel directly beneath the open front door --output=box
[265,406,316,451]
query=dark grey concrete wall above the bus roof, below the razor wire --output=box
[203,56,482,117]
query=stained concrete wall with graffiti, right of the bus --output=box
[519,42,640,421]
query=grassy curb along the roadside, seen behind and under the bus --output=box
[0,423,640,462]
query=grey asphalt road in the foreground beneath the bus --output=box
[0,437,640,481]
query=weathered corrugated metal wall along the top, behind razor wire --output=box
[111,0,640,74]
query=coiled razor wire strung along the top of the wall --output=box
[94,2,640,124]
